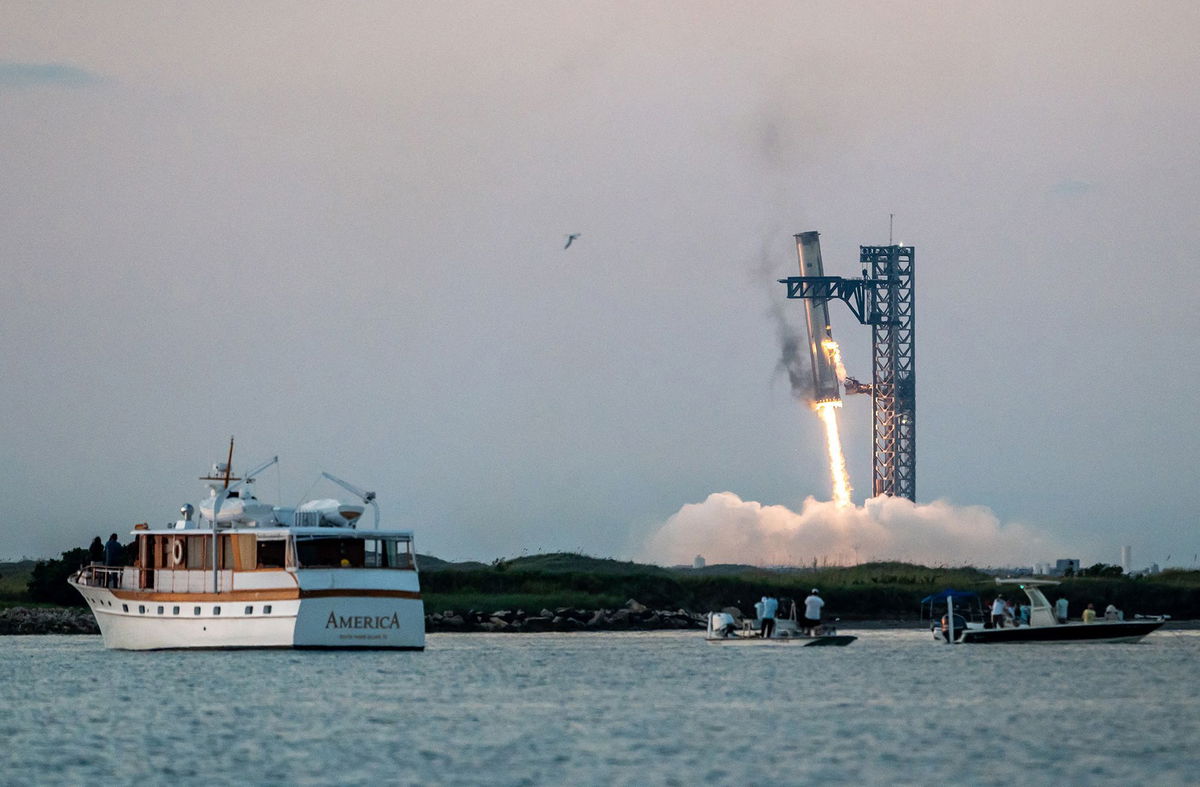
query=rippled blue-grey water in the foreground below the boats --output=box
[0,630,1200,786]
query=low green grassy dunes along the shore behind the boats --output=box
[9,553,1200,620]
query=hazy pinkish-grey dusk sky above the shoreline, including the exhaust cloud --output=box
[0,1,1200,566]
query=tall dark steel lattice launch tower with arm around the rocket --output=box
[780,246,917,500]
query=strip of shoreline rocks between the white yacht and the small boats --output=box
[425,599,704,633]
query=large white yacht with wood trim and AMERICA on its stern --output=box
[70,441,425,650]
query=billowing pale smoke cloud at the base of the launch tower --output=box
[638,492,1064,566]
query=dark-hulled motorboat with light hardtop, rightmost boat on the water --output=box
[935,579,1168,644]
